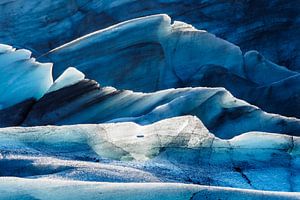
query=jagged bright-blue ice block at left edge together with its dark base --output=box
[0,44,53,127]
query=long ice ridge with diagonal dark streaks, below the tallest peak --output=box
[22,76,300,138]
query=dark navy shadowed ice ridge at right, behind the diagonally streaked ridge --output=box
[190,65,300,118]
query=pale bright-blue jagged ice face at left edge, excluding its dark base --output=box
[0,45,53,109]
